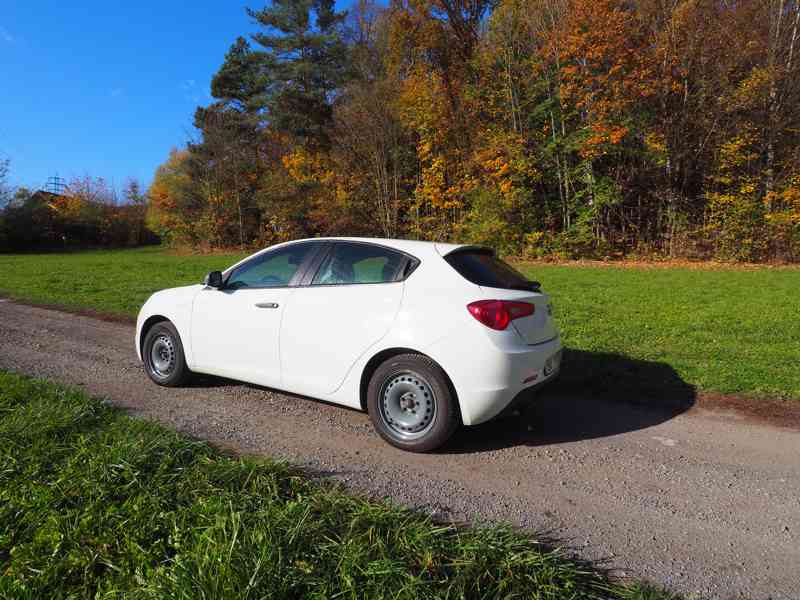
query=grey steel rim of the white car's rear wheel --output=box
[379,371,437,440]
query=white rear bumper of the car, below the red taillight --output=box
[433,337,562,425]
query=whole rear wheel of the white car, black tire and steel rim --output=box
[367,354,461,452]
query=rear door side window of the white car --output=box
[311,243,406,285]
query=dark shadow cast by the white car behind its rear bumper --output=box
[444,349,696,454]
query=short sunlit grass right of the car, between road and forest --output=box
[523,265,800,399]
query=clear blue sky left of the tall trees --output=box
[0,0,346,189]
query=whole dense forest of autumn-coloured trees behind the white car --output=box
[149,0,800,261]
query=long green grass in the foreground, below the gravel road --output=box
[0,372,671,600]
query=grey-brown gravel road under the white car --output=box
[0,300,800,598]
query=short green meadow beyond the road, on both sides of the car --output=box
[0,248,800,399]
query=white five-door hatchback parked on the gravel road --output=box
[136,238,561,452]
